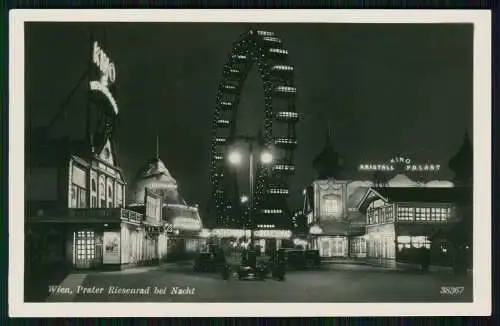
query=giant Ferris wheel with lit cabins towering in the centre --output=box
[210,30,299,227]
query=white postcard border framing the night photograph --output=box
[8,9,492,317]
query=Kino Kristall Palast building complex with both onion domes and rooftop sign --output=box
[303,126,472,267]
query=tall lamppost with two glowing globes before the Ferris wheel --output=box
[228,136,273,248]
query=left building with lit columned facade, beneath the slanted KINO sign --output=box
[26,138,164,269]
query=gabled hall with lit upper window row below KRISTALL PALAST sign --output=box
[358,188,461,267]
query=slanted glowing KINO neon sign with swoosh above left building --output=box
[90,42,118,114]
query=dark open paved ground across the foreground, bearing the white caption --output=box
[46,264,472,302]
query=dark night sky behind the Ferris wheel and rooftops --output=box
[25,23,473,222]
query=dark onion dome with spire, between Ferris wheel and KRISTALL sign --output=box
[313,125,344,180]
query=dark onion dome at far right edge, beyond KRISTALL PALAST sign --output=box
[448,132,474,186]
